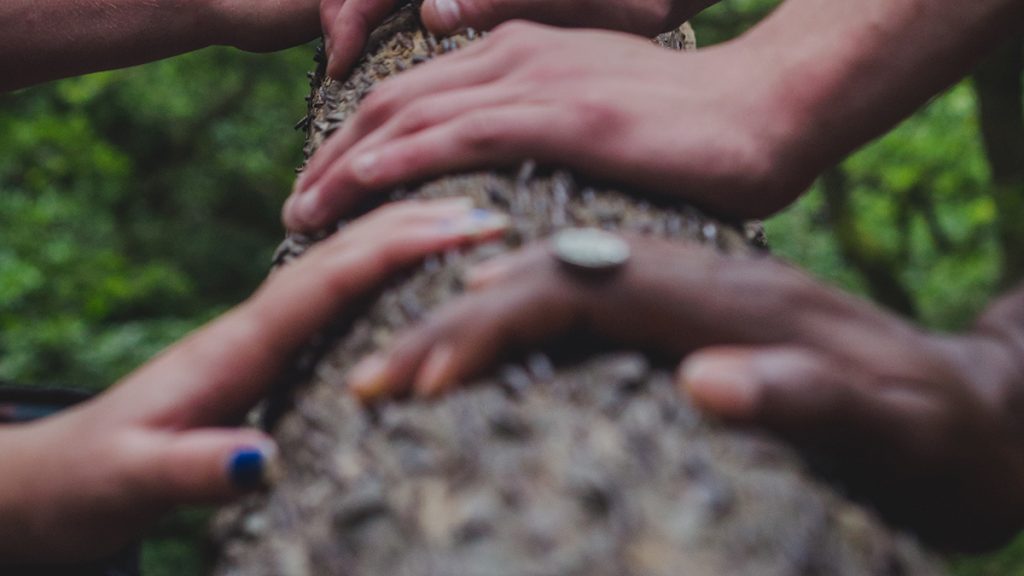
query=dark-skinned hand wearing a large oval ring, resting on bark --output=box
[349,239,1024,548]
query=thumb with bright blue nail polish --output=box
[130,429,278,505]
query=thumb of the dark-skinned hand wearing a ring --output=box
[679,347,920,450]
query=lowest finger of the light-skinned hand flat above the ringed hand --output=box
[290,105,579,229]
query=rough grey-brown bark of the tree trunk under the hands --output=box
[207,7,941,576]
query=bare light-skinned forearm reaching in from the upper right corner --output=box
[742,0,1024,169]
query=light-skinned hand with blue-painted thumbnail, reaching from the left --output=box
[0,200,505,562]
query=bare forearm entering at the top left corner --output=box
[0,0,219,92]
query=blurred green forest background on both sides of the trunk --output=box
[0,0,1024,576]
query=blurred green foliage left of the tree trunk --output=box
[0,43,311,388]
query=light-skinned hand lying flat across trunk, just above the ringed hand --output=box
[284,23,806,230]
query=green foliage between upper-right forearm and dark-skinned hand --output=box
[767,84,1000,329]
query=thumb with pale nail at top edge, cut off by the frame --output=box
[421,0,557,35]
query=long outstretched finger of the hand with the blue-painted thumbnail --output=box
[111,200,508,427]
